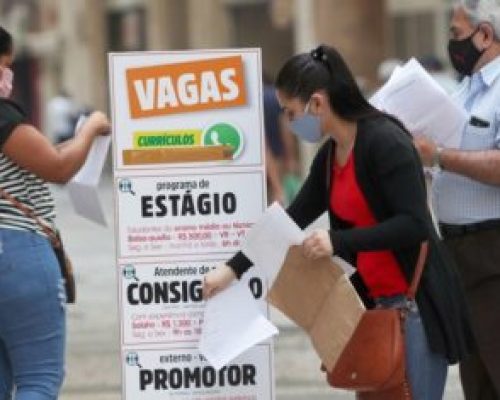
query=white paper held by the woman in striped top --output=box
[66,116,111,226]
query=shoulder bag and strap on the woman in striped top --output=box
[0,188,76,304]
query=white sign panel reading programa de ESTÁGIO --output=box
[116,171,265,257]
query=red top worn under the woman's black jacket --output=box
[330,152,408,297]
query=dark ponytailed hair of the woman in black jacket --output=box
[276,45,382,121]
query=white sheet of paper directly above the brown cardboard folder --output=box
[242,202,305,286]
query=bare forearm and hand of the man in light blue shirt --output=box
[414,136,500,186]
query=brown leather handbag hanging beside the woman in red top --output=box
[327,242,428,400]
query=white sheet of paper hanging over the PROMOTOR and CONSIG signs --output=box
[198,282,278,369]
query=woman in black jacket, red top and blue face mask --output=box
[204,46,473,400]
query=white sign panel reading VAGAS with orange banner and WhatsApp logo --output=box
[110,50,263,172]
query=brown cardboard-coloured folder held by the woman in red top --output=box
[267,246,364,370]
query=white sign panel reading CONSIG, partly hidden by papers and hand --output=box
[119,260,268,346]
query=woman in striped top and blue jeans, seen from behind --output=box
[0,27,110,400]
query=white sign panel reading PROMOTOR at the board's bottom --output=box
[123,345,274,400]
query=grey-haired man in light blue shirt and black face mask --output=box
[415,0,500,400]
